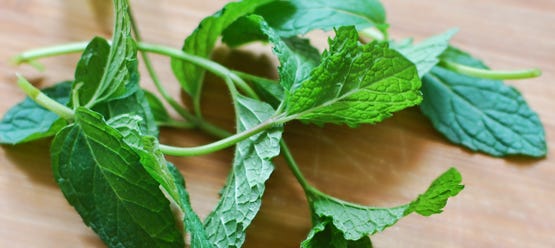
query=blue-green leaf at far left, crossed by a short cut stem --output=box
[0,82,71,145]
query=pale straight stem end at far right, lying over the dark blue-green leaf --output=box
[440,60,542,80]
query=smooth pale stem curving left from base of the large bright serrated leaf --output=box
[160,118,274,156]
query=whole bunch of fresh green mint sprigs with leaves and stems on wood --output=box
[0,0,547,247]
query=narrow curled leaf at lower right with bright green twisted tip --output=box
[303,168,464,243]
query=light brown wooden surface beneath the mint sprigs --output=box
[0,0,555,247]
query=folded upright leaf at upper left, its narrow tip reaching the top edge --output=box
[74,0,138,107]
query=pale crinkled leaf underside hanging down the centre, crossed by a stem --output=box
[204,96,282,247]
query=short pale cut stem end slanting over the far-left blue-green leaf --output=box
[17,74,75,120]
